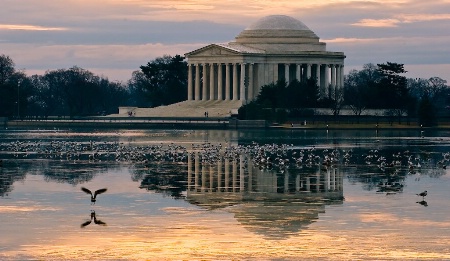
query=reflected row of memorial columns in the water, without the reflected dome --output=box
[187,153,343,193]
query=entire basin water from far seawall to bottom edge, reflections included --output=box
[0,129,450,260]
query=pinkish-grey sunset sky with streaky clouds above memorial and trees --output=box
[0,0,450,82]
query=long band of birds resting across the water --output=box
[0,138,450,173]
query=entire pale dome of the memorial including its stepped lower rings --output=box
[236,15,319,44]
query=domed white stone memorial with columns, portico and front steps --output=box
[119,15,345,117]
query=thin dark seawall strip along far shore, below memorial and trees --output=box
[4,118,450,130]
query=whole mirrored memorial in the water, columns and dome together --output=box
[187,153,344,239]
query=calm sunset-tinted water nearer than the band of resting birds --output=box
[0,129,450,260]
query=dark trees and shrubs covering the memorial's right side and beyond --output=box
[239,62,450,126]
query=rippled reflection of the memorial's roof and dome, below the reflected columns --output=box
[186,191,343,239]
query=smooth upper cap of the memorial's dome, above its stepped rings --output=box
[245,15,311,31]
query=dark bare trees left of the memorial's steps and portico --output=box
[0,54,187,119]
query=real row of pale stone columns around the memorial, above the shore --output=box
[188,63,344,101]
